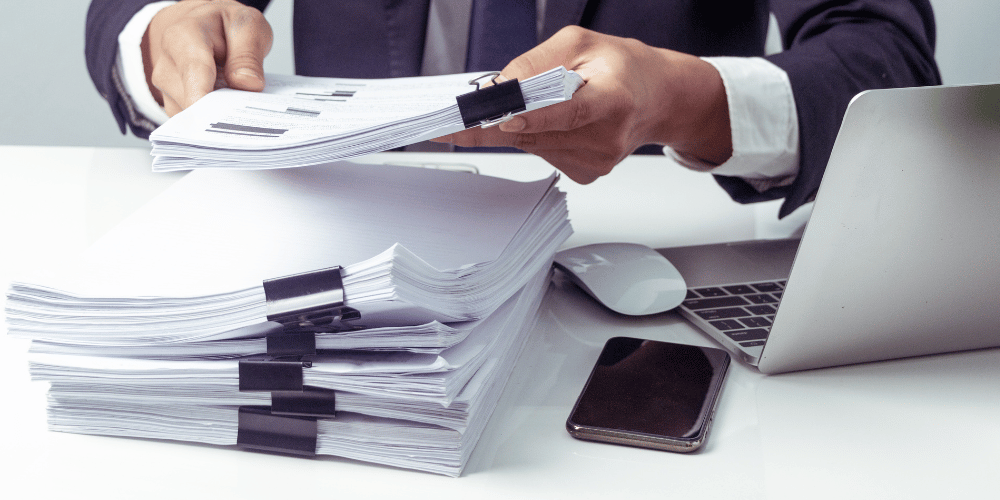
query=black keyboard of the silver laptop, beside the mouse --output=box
[680,280,786,348]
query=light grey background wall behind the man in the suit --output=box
[0,0,1000,146]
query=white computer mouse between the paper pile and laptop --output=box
[555,243,687,316]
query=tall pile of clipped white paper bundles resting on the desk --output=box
[6,162,572,475]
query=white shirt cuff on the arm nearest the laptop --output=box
[664,57,799,192]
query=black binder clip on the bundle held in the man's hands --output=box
[455,71,527,128]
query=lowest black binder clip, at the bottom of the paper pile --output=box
[236,406,319,457]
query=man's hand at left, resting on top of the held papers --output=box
[142,0,274,116]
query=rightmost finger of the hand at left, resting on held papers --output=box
[222,6,274,91]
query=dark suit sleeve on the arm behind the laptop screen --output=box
[716,0,941,217]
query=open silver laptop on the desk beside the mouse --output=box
[660,84,1000,373]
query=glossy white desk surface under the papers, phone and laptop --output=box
[0,147,1000,499]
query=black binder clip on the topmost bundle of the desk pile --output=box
[264,266,361,332]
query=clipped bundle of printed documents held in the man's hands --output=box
[149,67,583,171]
